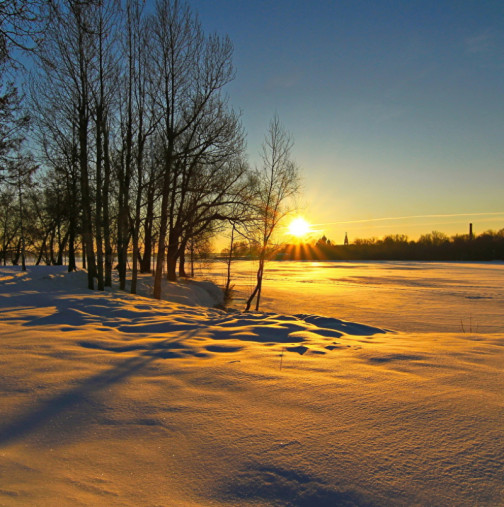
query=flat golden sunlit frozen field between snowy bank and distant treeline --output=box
[203,261,504,333]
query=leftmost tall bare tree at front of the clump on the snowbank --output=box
[34,0,104,289]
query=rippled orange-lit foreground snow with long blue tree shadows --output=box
[0,265,504,506]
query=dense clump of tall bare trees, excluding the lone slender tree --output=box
[23,0,256,298]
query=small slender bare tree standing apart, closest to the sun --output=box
[245,115,299,311]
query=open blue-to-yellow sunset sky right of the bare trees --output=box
[185,0,504,243]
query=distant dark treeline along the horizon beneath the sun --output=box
[281,229,504,261]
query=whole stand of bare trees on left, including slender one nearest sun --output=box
[0,0,298,307]
